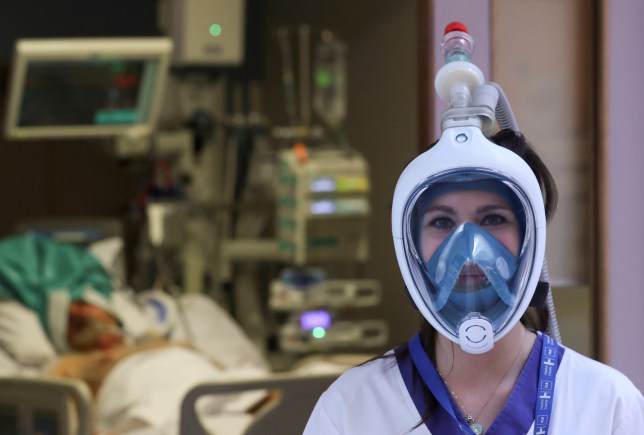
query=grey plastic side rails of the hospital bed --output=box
[0,373,339,435]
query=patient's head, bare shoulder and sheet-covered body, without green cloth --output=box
[47,292,268,435]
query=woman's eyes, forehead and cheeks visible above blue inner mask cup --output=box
[421,190,519,263]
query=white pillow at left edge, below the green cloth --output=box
[0,301,56,367]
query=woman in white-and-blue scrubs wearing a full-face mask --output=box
[305,126,644,435]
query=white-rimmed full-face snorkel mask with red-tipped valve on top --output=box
[392,21,546,354]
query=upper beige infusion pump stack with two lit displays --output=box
[277,146,371,265]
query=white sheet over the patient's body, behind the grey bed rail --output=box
[96,347,266,435]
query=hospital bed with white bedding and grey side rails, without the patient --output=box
[0,237,358,435]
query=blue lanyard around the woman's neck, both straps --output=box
[408,334,563,435]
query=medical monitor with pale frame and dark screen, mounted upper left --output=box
[5,37,172,139]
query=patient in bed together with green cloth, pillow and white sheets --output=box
[0,235,269,435]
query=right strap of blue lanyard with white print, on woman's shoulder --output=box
[534,334,560,435]
